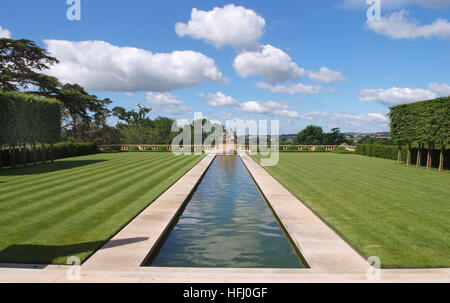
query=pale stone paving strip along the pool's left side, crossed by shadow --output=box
[82,154,216,270]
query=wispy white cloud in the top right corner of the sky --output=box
[365,10,450,39]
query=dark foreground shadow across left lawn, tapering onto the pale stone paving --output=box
[0,237,148,264]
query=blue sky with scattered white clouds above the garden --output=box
[0,0,450,133]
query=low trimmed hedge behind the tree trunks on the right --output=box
[356,144,450,169]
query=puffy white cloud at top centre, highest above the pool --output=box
[175,4,266,50]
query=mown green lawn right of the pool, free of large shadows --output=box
[254,153,450,268]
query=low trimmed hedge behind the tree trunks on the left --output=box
[1,142,98,166]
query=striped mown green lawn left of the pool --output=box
[0,153,202,264]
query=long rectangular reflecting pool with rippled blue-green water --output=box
[146,156,305,268]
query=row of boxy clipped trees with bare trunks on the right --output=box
[389,97,450,170]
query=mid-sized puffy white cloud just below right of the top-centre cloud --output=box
[233,45,306,83]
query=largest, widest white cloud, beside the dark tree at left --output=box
[44,40,227,92]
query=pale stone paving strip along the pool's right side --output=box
[240,153,369,273]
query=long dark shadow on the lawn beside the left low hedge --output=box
[0,160,107,177]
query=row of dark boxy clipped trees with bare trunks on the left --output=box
[0,90,62,167]
